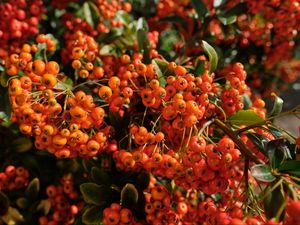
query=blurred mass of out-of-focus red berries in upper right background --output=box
[149,0,300,95]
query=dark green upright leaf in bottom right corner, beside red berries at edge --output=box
[264,185,284,219]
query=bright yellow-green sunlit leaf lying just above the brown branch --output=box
[228,109,266,126]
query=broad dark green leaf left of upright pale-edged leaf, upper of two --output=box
[80,183,111,205]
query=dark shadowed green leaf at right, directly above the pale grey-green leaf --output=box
[265,138,292,168]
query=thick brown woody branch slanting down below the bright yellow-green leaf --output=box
[214,119,265,164]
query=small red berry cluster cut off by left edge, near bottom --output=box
[0,165,29,191]
